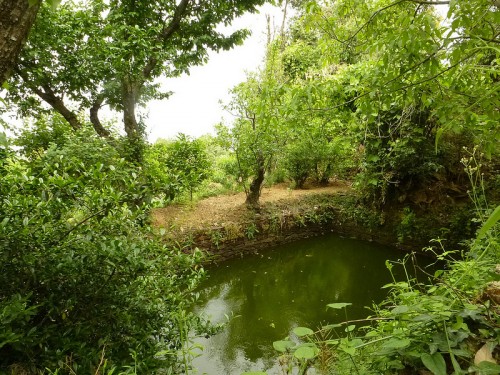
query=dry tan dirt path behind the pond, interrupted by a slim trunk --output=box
[153,182,350,231]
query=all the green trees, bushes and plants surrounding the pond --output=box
[0,0,500,374]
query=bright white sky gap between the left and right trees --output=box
[145,5,282,142]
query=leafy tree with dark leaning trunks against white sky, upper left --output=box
[6,0,265,159]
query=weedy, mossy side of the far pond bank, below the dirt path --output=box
[155,193,468,261]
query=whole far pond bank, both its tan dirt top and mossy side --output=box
[153,184,472,261]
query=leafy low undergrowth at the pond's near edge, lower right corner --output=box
[262,150,500,375]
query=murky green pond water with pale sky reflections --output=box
[193,235,430,375]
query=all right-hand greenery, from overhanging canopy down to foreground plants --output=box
[219,0,500,374]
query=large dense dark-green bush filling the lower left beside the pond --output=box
[0,131,207,373]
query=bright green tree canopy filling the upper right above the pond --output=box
[219,0,500,206]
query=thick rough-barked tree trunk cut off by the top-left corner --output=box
[0,0,40,84]
